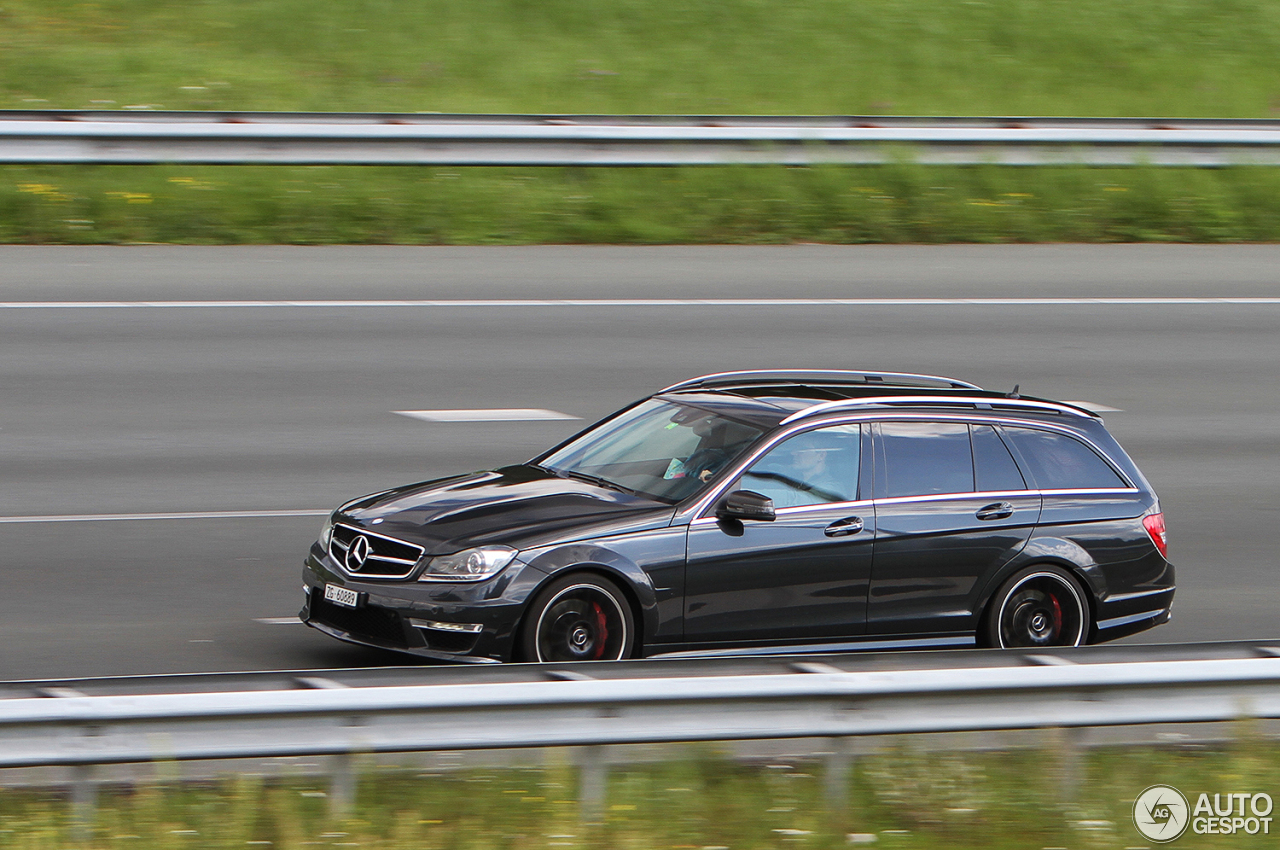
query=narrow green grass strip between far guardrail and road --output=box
[0,165,1280,245]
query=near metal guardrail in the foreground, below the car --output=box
[0,653,1280,767]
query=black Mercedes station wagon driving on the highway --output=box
[301,371,1174,662]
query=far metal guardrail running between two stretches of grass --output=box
[0,110,1280,166]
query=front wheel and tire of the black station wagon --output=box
[518,572,636,663]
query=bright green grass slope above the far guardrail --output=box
[0,0,1280,118]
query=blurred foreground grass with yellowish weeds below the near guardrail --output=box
[0,734,1280,850]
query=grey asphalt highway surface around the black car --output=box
[0,246,1280,680]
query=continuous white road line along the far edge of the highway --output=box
[0,297,1280,310]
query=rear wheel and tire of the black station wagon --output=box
[983,565,1089,649]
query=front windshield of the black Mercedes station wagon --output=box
[538,398,762,503]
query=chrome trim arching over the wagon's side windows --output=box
[671,410,1142,526]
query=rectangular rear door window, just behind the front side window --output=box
[877,422,973,498]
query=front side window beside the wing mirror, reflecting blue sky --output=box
[739,425,861,508]
